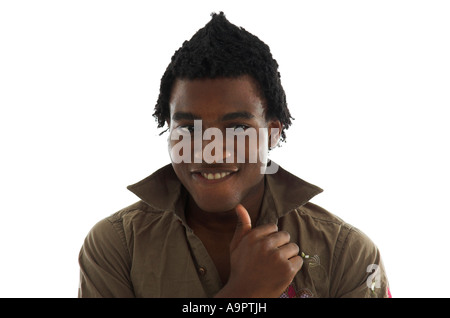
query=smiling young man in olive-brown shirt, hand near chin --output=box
[79,12,390,298]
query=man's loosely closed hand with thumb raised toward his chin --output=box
[216,204,303,298]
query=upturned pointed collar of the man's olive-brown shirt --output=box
[127,164,323,224]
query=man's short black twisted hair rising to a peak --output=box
[153,12,293,141]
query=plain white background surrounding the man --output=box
[0,0,450,297]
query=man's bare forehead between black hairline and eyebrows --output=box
[170,76,265,118]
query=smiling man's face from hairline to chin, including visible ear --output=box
[168,76,281,212]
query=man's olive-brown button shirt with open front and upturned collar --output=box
[78,165,390,298]
